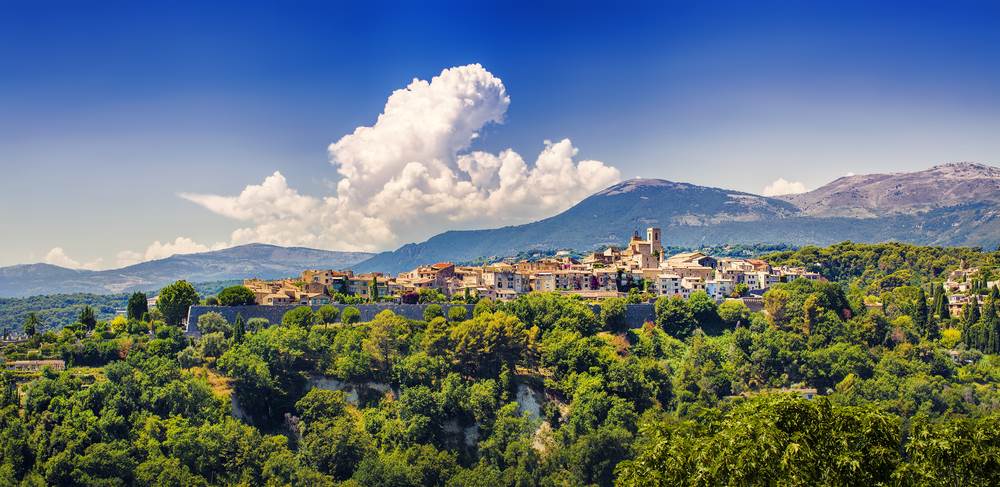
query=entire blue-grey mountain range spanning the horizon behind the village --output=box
[0,162,1000,297]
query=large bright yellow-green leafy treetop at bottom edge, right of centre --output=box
[617,395,901,486]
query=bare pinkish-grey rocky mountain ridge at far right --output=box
[779,162,1000,218]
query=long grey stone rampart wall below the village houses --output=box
[185,303,655,336]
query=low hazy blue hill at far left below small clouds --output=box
[0,244,371,297]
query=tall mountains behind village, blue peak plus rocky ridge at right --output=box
[355,163,1000,273]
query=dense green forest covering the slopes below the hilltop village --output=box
[0,244,1000,486]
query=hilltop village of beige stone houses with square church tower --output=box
[243,227,820,306]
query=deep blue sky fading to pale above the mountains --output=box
[0,1,1000,267]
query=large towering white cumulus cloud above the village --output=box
[180,64,621,250]
